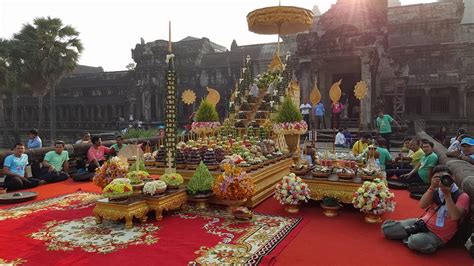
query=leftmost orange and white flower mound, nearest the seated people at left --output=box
[93,157,128,188]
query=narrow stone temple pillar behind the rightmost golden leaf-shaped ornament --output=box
[360,52,375,129]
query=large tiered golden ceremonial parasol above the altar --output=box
[247,3,314,70]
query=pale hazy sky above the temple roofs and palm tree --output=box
[0,0,434,71]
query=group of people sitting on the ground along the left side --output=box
[3,129,160,191]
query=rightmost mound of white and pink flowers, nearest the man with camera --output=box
[352,178,395,215]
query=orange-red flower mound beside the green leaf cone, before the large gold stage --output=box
[212,163,255,200]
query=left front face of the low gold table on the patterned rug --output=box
[93,198,149,229]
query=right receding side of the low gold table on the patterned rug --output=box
[144,188,188,221]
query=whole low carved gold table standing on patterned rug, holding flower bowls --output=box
[93,188,188,228]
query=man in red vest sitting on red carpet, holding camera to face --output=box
[382,165,469,253]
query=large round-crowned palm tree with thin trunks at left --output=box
[12,17,83,142]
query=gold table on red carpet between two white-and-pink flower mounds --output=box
[302,177,362,204]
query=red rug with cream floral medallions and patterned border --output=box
[0,192,301,265]
